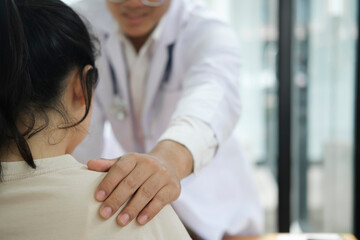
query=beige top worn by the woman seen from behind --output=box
[0,155,190,240]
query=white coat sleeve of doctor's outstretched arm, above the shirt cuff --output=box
[172,19,240,148]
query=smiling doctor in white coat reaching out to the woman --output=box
[75,0,262,239]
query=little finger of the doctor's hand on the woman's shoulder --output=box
[137,185,180,225]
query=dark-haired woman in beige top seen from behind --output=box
[0,0,189,240]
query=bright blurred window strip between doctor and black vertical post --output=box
[209,0,278,232]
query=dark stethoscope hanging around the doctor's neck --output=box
[107,43,175,120]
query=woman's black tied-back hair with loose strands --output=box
[0,0,97,179]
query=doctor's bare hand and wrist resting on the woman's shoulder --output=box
[88,140,193,226]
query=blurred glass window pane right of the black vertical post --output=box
[292,0,358,232]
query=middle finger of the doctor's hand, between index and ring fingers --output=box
[100,161,152,219]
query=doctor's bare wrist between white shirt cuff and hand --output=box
[149,140,194,180]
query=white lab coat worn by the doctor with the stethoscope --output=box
[77,0,263,239]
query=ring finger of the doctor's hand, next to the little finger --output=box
[117,174,167,226]
